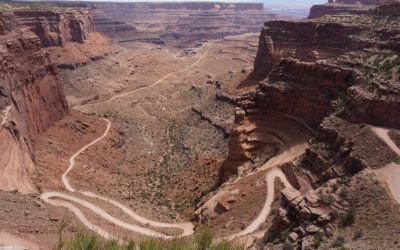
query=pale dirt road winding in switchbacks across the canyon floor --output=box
[41,41,300,240]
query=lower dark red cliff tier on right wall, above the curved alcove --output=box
[254,59,357,126]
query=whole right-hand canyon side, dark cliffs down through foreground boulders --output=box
[222,4,400,249]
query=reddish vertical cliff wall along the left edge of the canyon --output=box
[0,10,94,193]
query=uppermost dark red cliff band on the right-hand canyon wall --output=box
[254,21,362,79]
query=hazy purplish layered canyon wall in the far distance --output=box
[53,2,276,47]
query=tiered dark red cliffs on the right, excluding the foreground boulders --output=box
[225,8,400,183]
